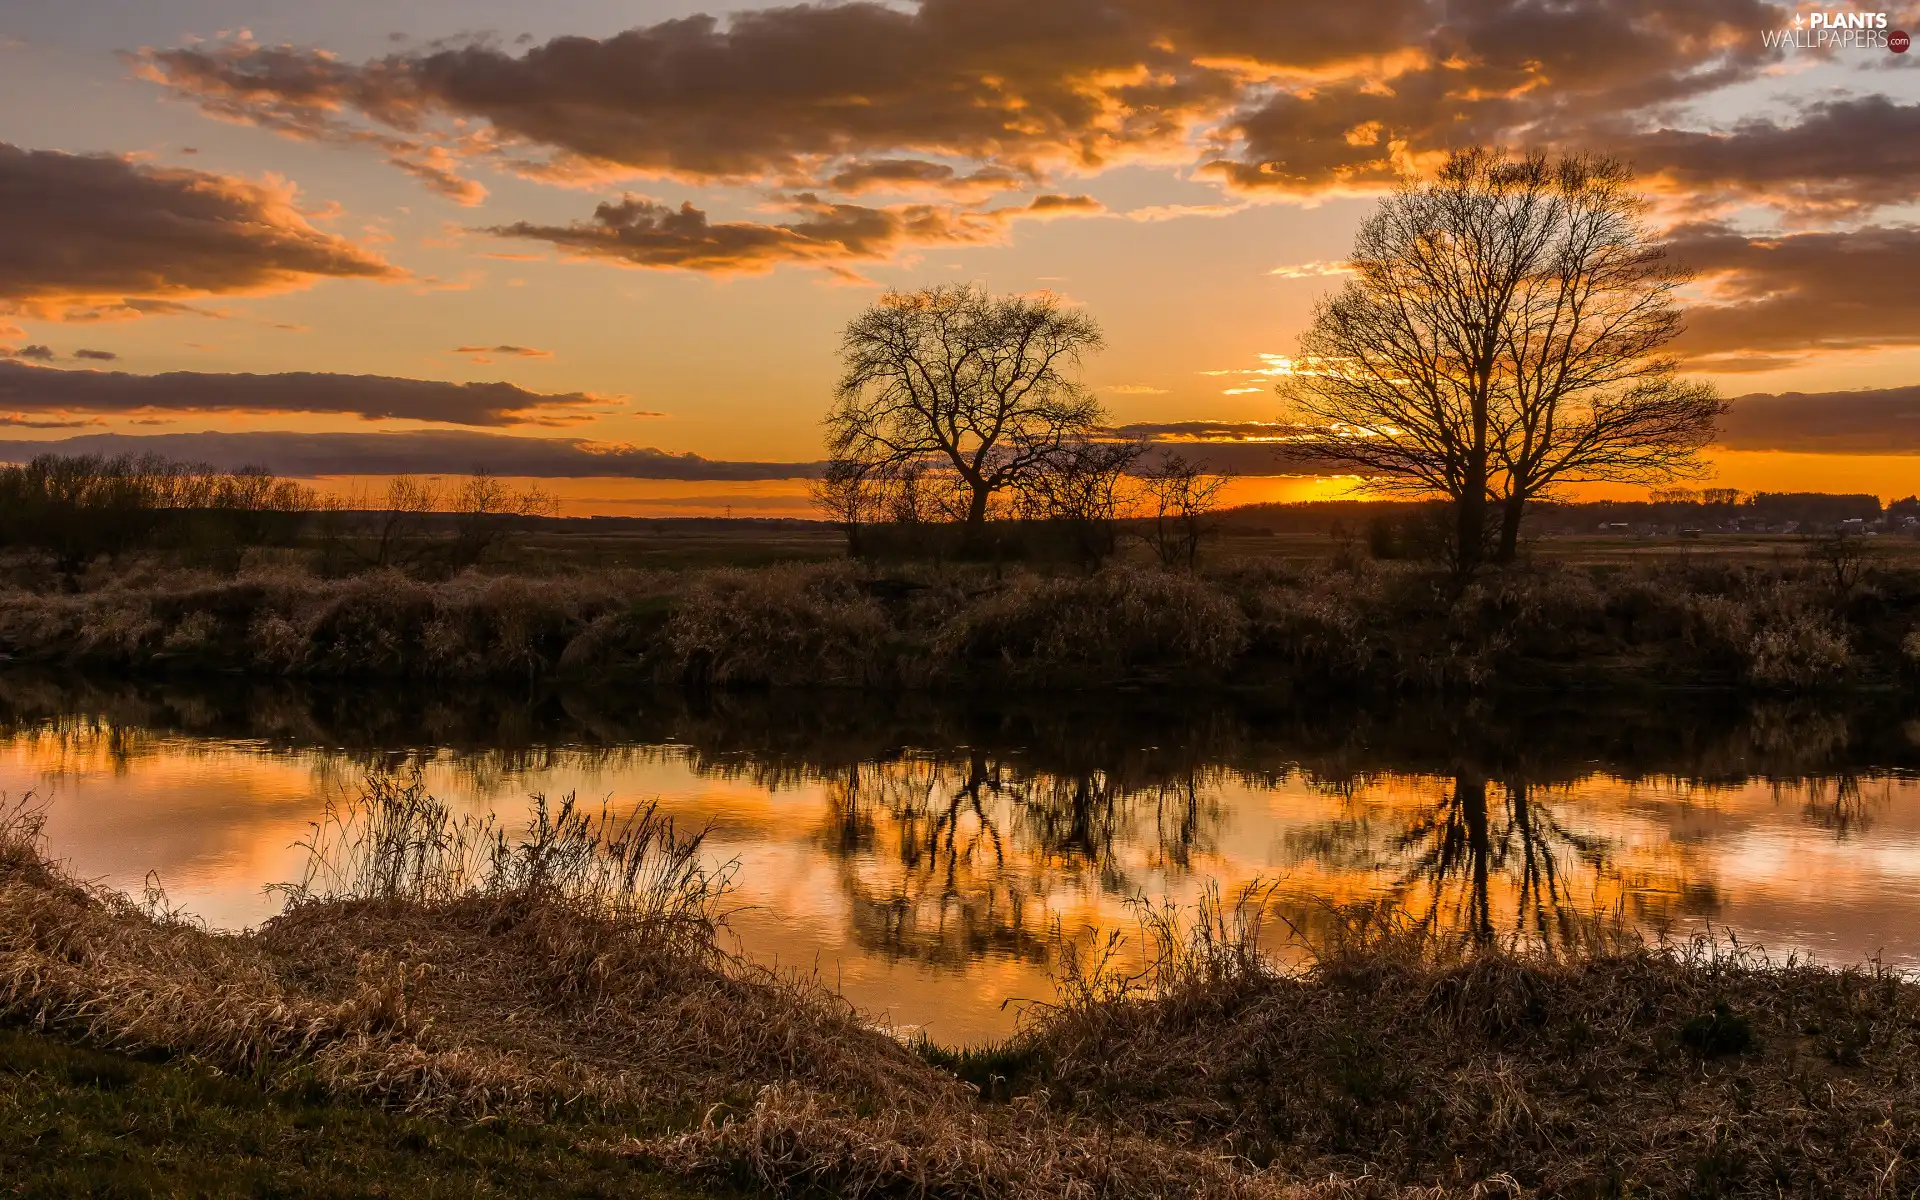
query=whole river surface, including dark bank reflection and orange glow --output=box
[0,676,1920,1043]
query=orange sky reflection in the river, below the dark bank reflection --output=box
[0,687,1920,1041]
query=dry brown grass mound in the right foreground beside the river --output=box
[1000,895,1920,1196]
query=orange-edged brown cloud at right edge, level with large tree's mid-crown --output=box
[1668,225,1920,371]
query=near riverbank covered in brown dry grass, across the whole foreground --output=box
[0,789,1920,1198]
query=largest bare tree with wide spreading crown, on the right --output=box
[1279,148,1720,572]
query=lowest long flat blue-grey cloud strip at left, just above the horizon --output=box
[0,430,822,482]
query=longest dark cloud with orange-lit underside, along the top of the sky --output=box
[120,0,1442,186]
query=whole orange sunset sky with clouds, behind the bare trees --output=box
[0,0,1920,515]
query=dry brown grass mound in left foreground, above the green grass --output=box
[0,781,1328,1198]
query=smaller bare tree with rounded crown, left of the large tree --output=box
[826,286,1102,536]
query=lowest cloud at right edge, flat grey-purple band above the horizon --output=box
[1718,386,1920,453]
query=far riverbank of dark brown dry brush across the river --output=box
[0,557,1920,695]
